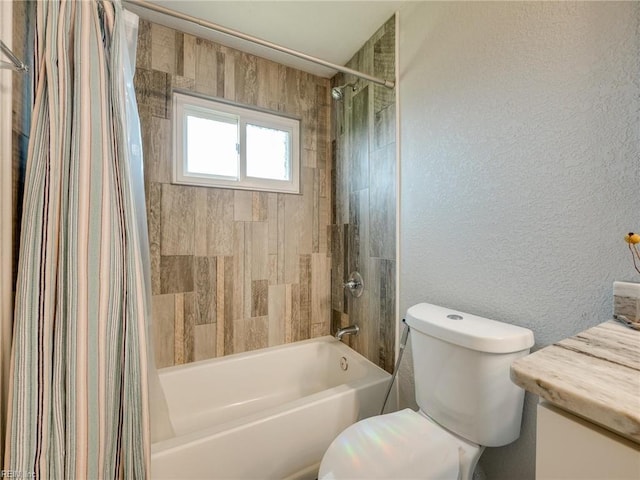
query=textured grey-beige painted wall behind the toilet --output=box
[398,1,640,480]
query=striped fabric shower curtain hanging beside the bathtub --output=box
[3,0,149,479]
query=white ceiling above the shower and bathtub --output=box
[126,0,405,78]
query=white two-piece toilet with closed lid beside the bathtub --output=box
[318,303,534,480]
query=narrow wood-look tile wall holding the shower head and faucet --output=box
[331,17,396,371]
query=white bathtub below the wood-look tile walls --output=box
[151,336,391,480]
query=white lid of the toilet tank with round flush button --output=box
[406,303,534,353]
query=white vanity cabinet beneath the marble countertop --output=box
[536,402,640,480]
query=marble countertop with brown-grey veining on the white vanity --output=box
[511,320,640,443]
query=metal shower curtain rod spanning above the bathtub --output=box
[123,0,395,88]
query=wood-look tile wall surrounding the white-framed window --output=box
[135,21,332,367]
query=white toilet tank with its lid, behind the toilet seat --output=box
[406,303,534,447]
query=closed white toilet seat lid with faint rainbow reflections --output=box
[318,409,460,480]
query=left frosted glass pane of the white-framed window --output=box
[187,115,239,178]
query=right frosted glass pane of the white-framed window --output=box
[247,123,291,180]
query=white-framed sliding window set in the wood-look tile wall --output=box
[173,92,300,193]
